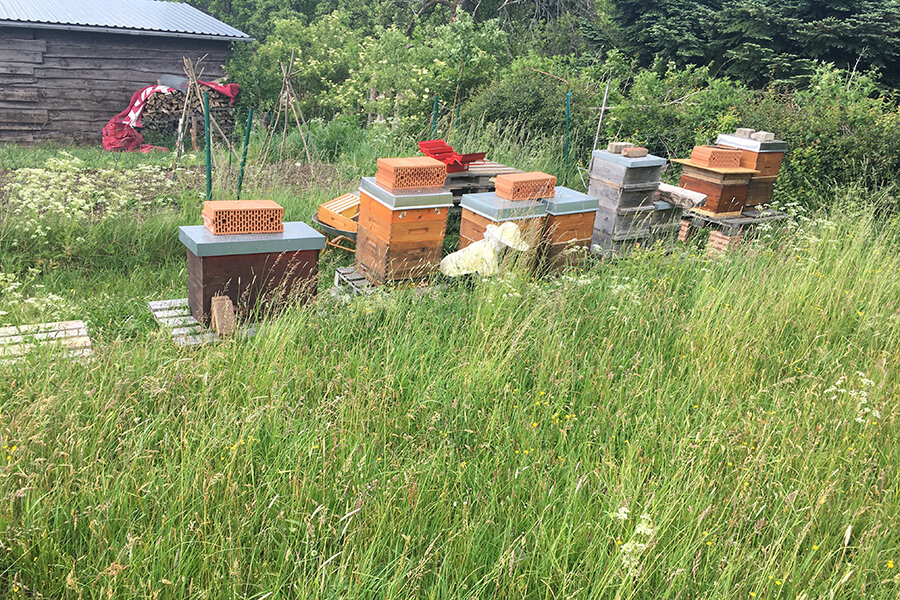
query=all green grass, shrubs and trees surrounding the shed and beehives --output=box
[0,0,900,600]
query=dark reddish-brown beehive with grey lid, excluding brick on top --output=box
[178,222,325,323]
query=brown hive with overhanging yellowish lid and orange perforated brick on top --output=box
[675,146,757,215]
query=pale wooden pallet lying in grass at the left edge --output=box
[0,321,91,363]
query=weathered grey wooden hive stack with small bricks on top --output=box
[588,142,681,255]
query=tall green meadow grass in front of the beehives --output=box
[0,138,900,600]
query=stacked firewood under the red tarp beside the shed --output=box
[141,89,234,136]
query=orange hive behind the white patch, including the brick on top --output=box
[459,171,557,250]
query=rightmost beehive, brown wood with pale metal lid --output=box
[716,129,787,207]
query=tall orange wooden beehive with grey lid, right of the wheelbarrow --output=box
[356,177,453,284]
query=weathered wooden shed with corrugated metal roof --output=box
[0,0,251,143]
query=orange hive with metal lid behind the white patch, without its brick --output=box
[459,192,547,249]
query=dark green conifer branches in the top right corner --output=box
[593,0,900,86]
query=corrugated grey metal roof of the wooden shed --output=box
[0,0,251,41]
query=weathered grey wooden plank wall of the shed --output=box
[0,27,230,144]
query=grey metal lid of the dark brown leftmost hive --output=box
[178,221,325,256]
